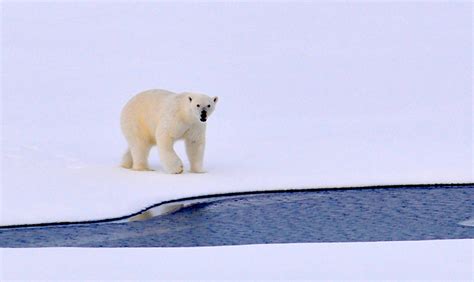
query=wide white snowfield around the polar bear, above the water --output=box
[0,1,473,225]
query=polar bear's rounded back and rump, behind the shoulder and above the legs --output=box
[120,89,176,143]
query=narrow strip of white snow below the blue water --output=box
[0,239,474,281]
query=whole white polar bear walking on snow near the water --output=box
[121,90,217,173]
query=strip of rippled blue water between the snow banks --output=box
[0,185,474,247]
